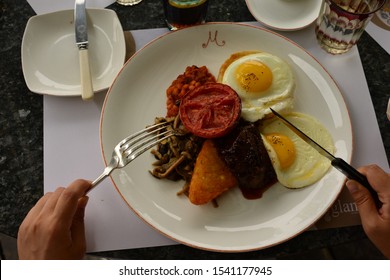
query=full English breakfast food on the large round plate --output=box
[150,51,335,205]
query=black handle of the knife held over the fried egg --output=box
[332,158,382,208]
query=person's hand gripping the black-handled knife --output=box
[346,165,390,259]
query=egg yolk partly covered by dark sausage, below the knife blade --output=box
[265,133,295,169]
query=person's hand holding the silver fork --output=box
[17,179,91,260]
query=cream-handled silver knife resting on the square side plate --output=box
[74,0,93,100]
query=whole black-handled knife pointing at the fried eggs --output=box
[270,108,382,208]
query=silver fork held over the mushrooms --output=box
[86,122,175,193]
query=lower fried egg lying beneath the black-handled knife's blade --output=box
[260,112,335,189]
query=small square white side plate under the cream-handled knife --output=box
[22,9,126,96]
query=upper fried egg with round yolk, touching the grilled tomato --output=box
[221,52,295,122]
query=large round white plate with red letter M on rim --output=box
[100,23,352,252]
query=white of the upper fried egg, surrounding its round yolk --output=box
[222,52,295,122]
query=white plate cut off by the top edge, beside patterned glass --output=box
[245,0,322,31]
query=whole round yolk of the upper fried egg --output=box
[236,60,272,93]
